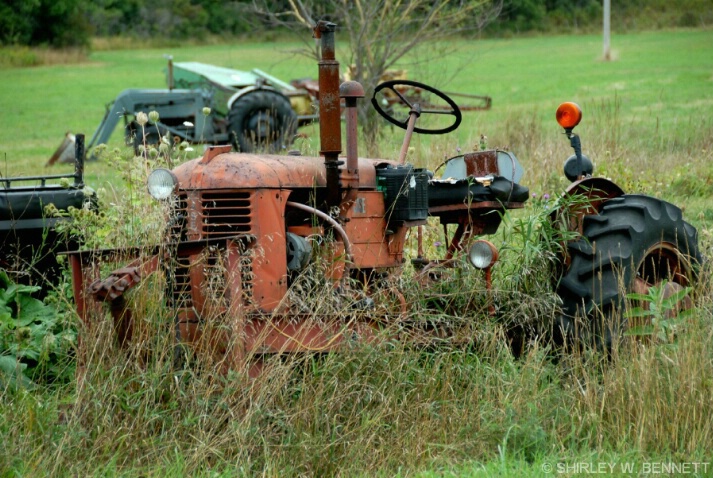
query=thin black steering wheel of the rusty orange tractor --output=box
[371,80,463,134]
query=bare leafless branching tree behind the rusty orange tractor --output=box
[248,0,503,153]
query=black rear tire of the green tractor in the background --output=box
[228,90,297,153]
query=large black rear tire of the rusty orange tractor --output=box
[554,195,701,351]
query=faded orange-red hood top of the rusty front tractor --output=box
[173,153,386,190]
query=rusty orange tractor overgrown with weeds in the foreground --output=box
[64,22,700,375]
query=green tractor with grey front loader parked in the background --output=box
[48,57,318,165]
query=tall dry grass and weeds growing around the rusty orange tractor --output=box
[0,101,713,476]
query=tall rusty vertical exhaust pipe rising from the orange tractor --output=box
[314,20,342,210]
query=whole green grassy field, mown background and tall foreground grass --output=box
[0,30,713,477]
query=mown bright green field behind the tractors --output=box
[0,31,713,185]
